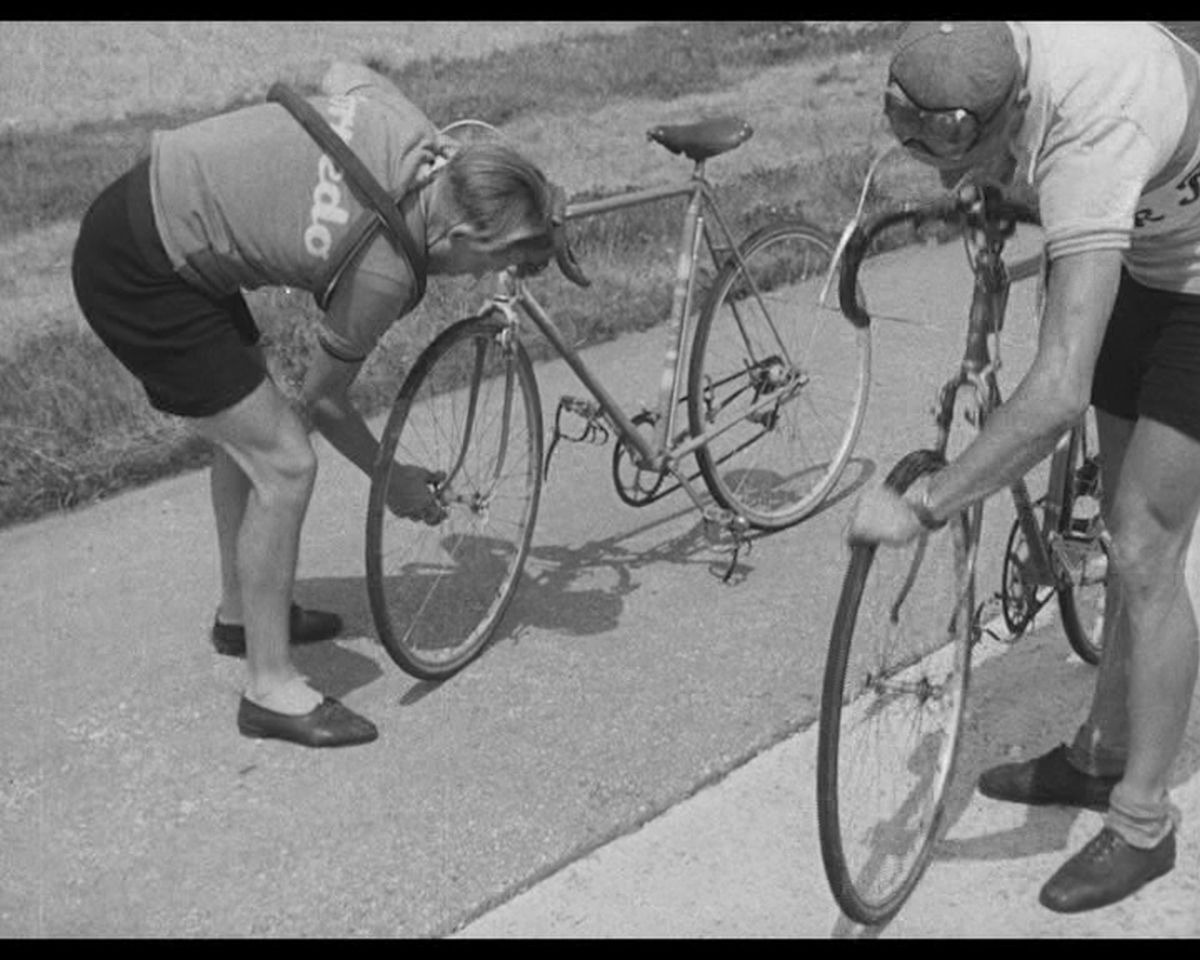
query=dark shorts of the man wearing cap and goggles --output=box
[1092,264,1200,442]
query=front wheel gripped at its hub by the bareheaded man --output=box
[366,314,542,680]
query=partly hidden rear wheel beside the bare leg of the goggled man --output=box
[1056,415,1109,666]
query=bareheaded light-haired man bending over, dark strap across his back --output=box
[72,64,556,746]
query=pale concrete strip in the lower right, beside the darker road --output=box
[457,623,1200,940]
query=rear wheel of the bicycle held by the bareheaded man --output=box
[688,221,871,530]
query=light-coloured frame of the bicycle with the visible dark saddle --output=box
[472,161,791,510]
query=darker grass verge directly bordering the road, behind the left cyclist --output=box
[0,156,936,527]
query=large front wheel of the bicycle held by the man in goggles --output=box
[817,450,980,925]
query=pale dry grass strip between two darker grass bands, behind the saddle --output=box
[0,30,902,355]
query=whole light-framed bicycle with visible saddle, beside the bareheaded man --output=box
[366,118,870,680]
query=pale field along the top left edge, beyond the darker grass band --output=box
[0,20,638,131]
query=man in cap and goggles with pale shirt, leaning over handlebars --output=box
[848,22,1200,912]
